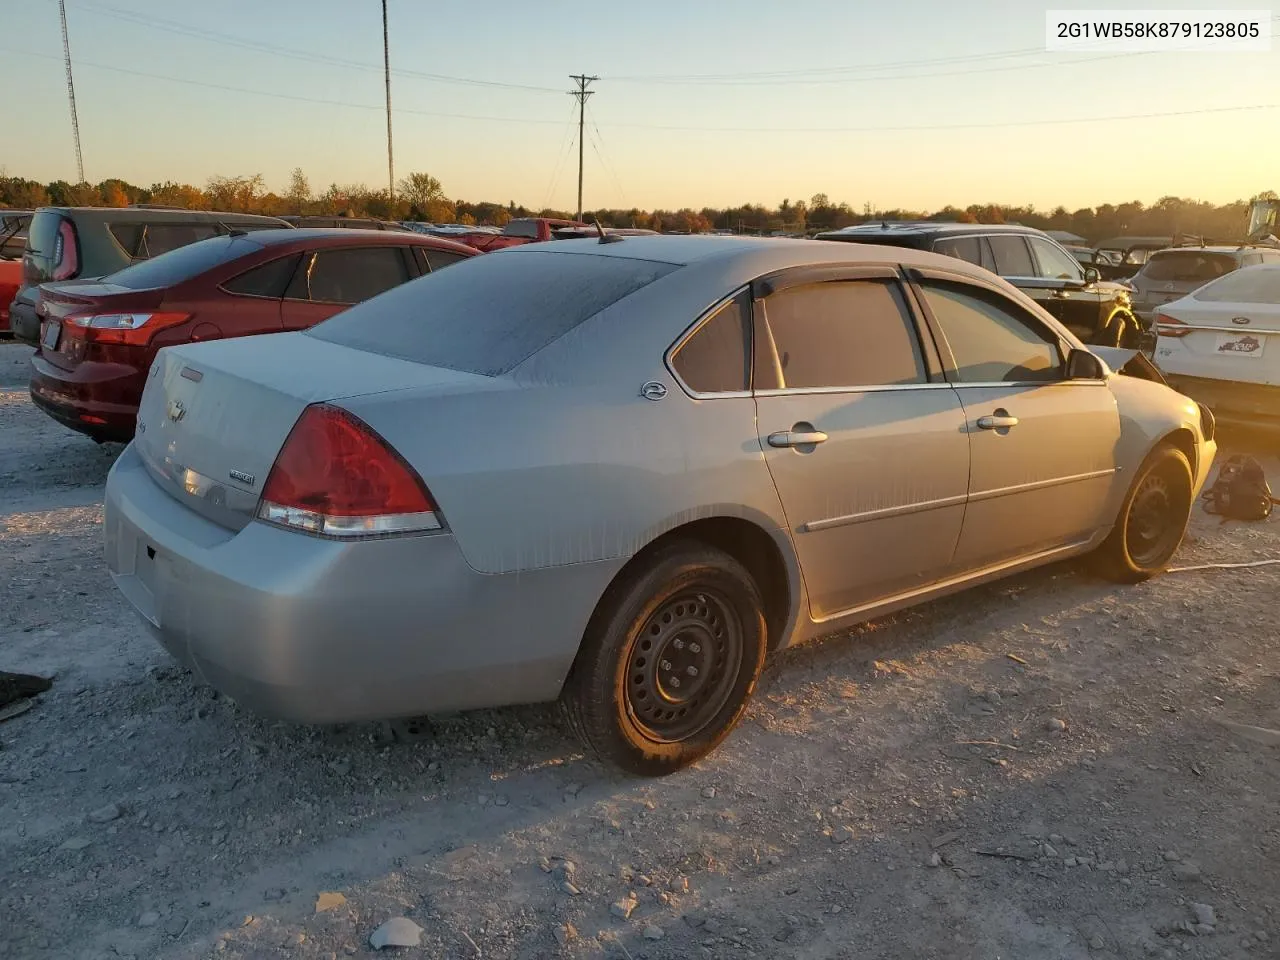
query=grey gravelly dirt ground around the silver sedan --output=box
[0,344,1280,960]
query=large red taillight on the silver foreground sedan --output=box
[257,403,440,538]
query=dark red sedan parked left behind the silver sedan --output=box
[31,229,476,443]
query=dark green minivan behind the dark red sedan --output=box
[10,206,288,346]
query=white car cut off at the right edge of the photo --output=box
[1155,262,1280,425]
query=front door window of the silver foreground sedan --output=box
[923,280,1062,383]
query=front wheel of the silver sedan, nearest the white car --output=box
[1094,443,1194,584]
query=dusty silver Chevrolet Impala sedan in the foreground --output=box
[104,237,1216,774]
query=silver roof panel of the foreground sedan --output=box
[485,233,992,280]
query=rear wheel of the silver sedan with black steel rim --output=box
[561,541,768,777]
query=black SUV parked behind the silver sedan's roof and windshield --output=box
[817,221,1142,347]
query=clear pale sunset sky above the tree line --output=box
[0,0,1280,209]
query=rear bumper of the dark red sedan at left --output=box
[29,353,146,443]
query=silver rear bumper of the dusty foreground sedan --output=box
[104,445,622,723]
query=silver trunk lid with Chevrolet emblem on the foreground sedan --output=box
[133,333,489,530]
